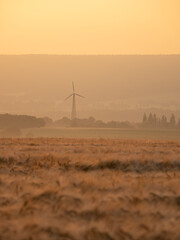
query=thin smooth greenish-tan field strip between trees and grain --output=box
[22,127,180,140]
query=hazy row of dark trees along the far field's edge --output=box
[0,113,180,131]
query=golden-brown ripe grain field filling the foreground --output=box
[0,138,180,240]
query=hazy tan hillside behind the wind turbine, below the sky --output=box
[0,55,180,121]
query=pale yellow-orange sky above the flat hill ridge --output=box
[0,0,180,54]
